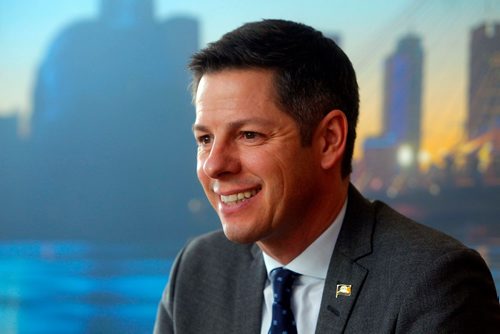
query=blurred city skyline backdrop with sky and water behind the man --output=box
[0,0,500,333]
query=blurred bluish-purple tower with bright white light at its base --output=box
[364,34,423,187]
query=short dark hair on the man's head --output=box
[189,20,359,177]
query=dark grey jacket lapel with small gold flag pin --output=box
[316,185,374,333]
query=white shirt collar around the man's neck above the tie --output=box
[262,199,347,279]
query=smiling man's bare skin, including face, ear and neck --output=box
[194,69,348,263]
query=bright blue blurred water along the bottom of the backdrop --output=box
[0,242,500,334]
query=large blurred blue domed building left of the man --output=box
[16,0,216,243]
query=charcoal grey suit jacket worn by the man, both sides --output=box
[154,186,500,334]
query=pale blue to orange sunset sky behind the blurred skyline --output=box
[0,0,500,166]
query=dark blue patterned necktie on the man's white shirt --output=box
[269,268,299,334]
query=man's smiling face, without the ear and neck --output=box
[193,70,319,243]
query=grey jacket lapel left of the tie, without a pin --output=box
[234,244,267,334]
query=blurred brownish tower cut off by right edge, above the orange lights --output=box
[467,23,500,139]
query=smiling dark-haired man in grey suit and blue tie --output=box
[155,20,500,334]
